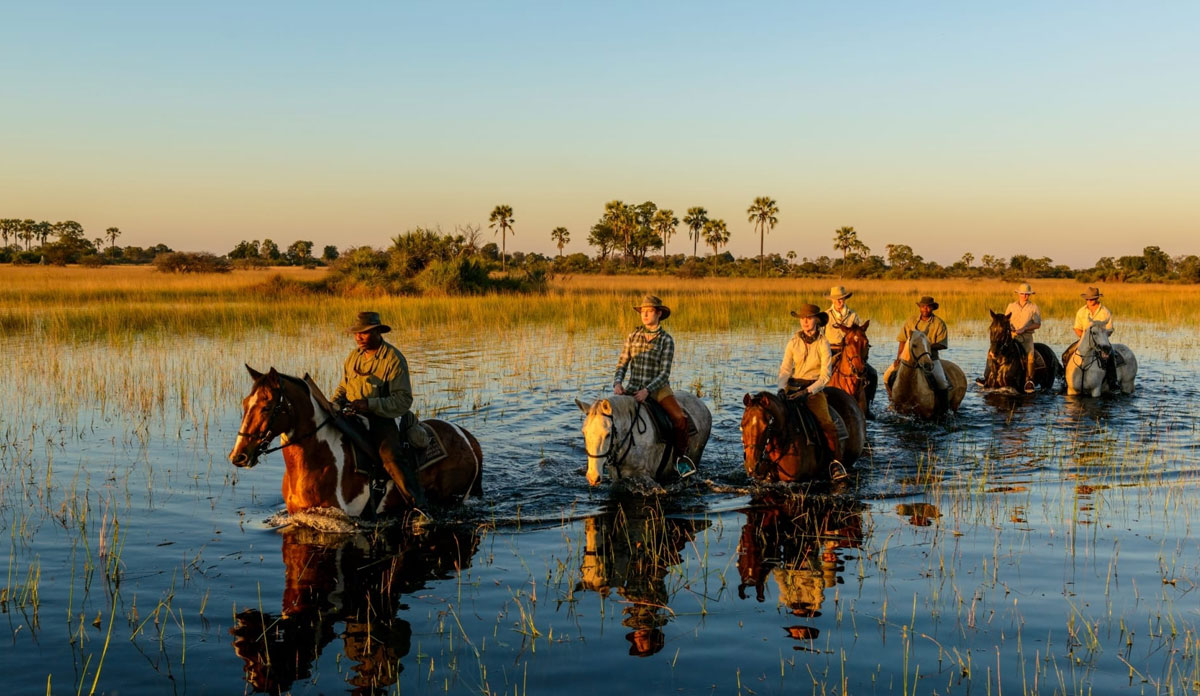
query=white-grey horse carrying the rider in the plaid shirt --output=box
[575,392,713,486]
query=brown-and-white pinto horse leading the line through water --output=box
[229,365,484,517]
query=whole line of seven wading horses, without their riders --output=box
[229,312,1138,517]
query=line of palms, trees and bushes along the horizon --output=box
[0,206,1200,282]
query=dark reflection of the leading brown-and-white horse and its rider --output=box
[229,526,479,695]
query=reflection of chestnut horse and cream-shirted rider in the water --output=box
[738,493,863,650]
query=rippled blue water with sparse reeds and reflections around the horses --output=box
[0,325,1200,694]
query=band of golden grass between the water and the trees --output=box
[0,266,1200,341]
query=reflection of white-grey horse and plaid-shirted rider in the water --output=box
[576,504,709,658]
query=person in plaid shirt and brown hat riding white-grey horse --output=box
[612,295,696,476]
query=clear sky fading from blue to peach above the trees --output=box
[0,0,1200,268]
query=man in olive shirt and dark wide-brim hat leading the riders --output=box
[330,312,427,510]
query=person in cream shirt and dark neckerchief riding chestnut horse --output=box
[779,305,848,481]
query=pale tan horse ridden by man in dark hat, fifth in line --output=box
[883,330,967,419]
